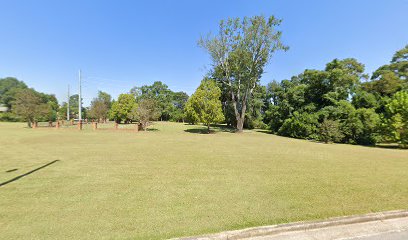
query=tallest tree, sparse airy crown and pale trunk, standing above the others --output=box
[199,16,287,132]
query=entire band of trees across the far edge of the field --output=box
[0,16,408,147]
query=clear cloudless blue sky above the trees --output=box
[0,0,408,105]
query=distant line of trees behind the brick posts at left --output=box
[0,78,188,130]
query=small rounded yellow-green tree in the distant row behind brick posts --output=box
[110,93,137,123]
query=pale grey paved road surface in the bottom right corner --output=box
[250,217,408,240]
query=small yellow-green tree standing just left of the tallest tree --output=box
[186,79,224,132]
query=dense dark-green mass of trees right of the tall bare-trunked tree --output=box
[264,49,408,145]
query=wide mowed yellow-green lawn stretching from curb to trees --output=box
[0,122,408,239]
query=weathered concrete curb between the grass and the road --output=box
[173,210,408,240]
